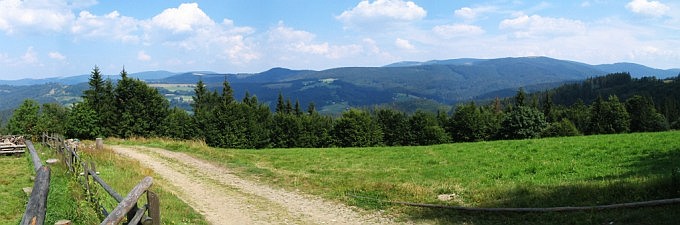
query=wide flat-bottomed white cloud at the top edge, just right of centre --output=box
[336,0,427,27]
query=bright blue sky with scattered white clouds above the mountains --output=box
[0,0,680,80]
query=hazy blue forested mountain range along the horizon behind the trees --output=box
[0,57,680,112]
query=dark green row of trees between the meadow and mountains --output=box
[5,67,680,149]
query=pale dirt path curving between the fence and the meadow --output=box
[112,146,402,224]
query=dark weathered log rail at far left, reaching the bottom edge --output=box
[21,166,50,225]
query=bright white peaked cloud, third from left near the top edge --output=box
[151,3,215,33]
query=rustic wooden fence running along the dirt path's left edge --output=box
[42,135,160,225]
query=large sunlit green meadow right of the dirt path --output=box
[115,131,680,224]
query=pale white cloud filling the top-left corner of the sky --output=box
[0,0,74,34]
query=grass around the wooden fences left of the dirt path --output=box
[0,142,207,224]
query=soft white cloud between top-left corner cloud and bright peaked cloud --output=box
[71,11,141,43]
